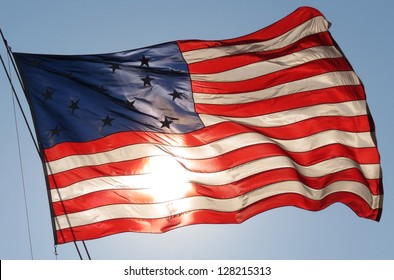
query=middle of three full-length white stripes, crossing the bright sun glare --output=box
[51,156,380,202]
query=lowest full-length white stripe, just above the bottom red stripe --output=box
[56,181,381,230]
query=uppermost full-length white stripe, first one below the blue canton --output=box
[46,130,375,175]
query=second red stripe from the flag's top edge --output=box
[188,32,334,74]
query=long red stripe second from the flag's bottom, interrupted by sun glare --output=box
[53,168,380,216]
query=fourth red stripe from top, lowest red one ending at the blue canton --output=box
[195,85,365,117]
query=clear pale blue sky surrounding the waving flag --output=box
[0,0,394,259]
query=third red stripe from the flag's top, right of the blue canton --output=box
[192,57,352,94]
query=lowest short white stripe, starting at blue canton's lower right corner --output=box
[199,100,367,127]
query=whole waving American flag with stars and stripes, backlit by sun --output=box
[14,7,383,244]
